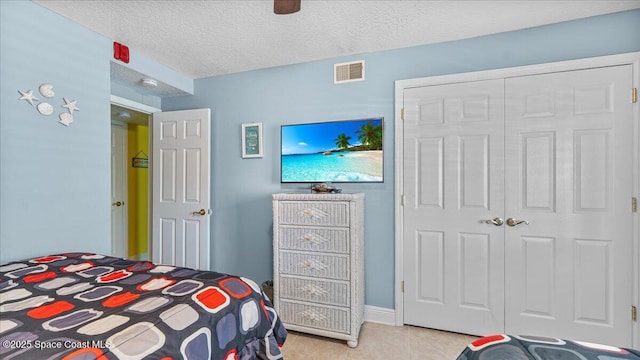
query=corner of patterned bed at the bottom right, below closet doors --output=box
[457,334,640,360]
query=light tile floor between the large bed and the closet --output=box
[282,322,477,360]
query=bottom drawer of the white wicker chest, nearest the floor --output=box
[278,299,351,334]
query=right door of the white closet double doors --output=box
[505,65,633,346]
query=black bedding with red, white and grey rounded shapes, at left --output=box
[0,253,287,360]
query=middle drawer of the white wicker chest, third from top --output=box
[278,250,349,280]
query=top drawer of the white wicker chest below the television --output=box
[278,201,349,227]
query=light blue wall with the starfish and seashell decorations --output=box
[0,1,111,263]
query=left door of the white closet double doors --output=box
[403,79,504,334]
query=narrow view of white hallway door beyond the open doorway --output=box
[111,123,128,258]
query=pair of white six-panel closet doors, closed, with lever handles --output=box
[396,57,637,346]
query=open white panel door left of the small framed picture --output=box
[151,109,211,270]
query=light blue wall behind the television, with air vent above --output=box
[162,10,640,308]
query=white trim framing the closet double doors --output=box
[394,52,640,348]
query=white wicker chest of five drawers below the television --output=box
[272,193,364,347]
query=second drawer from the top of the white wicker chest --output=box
[278,226,349,254]
